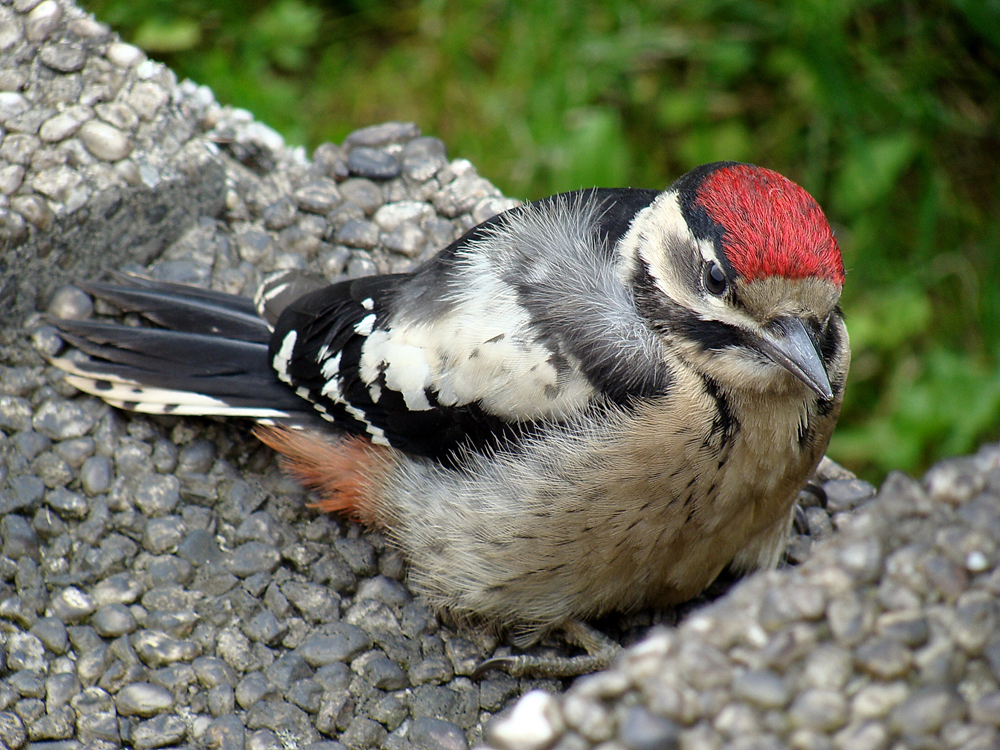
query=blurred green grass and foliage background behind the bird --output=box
[83,0,1000,480]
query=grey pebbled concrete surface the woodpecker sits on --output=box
[0,0,1000,750]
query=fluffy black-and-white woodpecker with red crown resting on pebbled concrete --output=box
[55,162,850,680]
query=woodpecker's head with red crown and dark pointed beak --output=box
[620,162,847,401]
